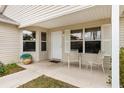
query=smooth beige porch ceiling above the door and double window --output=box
[33,5,111,29]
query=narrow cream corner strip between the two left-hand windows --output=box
[36,31,41,62]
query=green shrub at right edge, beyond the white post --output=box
[120,48,124,87]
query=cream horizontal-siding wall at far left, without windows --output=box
[0,22,20,64]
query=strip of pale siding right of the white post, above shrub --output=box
[120,18,124,47]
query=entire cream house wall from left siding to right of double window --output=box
[0,19,111,63]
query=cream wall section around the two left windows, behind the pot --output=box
[20,27,48,62]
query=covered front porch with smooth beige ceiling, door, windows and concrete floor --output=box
[17,6,112,87]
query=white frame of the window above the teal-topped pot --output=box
[22,30,36,52]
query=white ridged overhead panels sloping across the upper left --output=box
[3,5,92,27]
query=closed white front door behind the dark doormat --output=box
[51,31,62,60]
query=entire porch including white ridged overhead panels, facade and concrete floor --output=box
[0,5,112,87]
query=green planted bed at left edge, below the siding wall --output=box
[0,63,25,77]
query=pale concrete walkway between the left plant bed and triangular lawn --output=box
[0,69,42,88]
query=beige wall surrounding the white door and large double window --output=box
[49,19,112,61]
